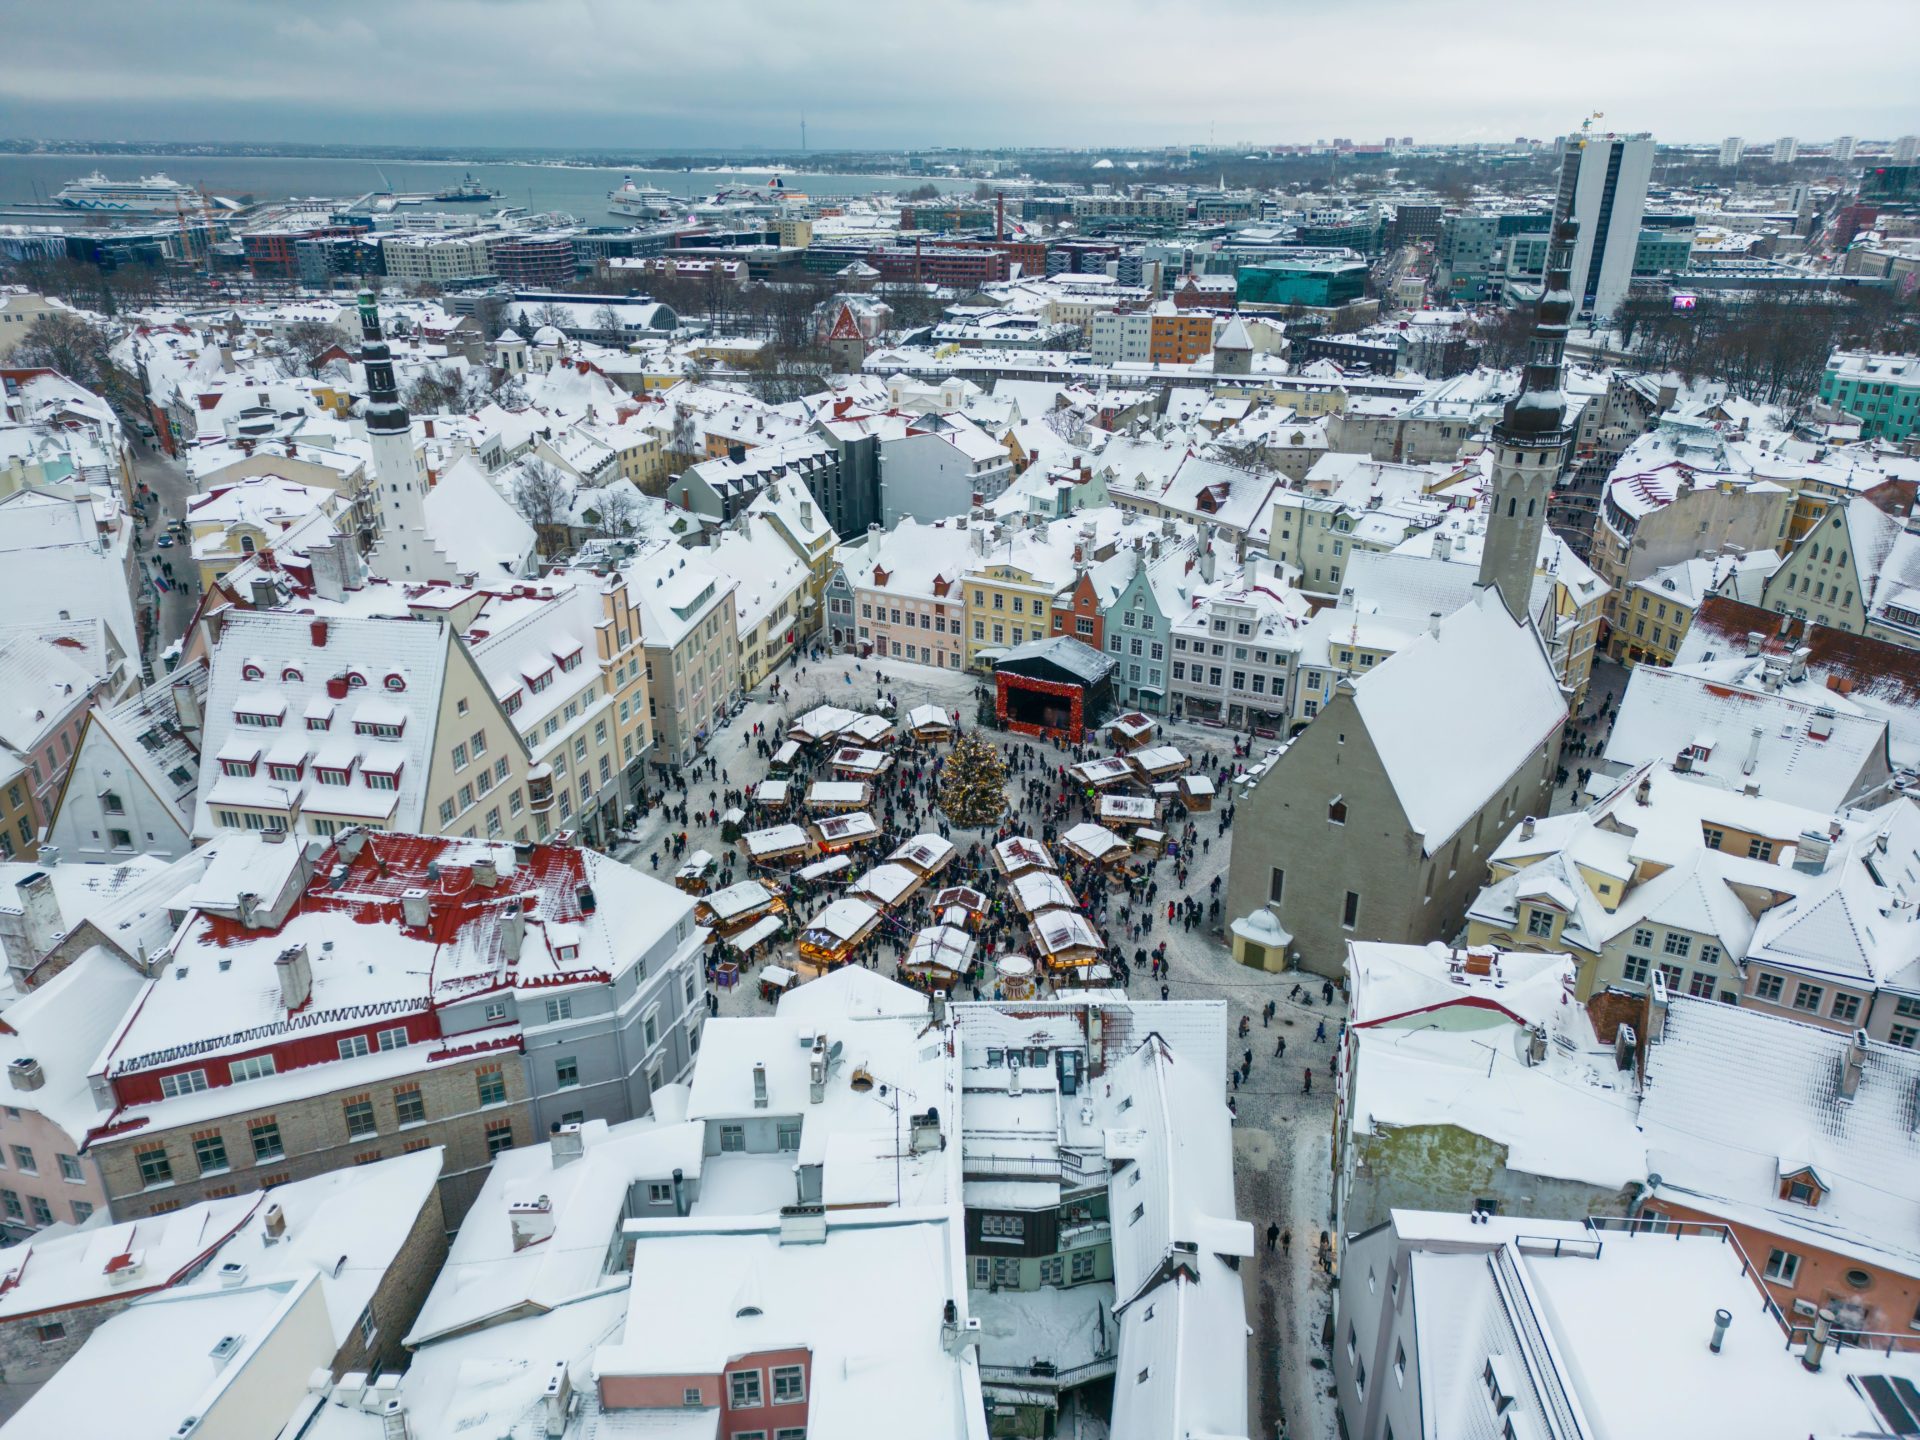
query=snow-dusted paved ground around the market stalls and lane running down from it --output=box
[620,657,1346,1440]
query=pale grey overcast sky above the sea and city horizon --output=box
[0,0,1920,150]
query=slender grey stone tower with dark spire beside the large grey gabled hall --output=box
[1480,216,1566,622]
